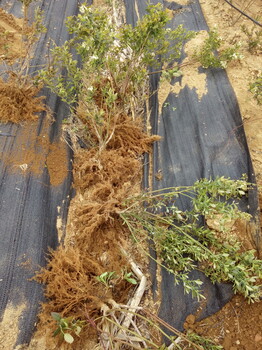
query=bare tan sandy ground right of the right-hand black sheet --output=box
[200,0,262,185]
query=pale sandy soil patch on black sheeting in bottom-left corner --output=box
[0,304,26,350]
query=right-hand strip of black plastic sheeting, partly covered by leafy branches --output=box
[125,0,259,332]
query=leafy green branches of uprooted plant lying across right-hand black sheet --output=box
[120,177,262,301]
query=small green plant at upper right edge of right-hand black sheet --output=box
[194,29,243,68]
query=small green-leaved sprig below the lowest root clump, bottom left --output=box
[51,312,86,344]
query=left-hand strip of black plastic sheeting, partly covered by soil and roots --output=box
[0,0,89,344]
